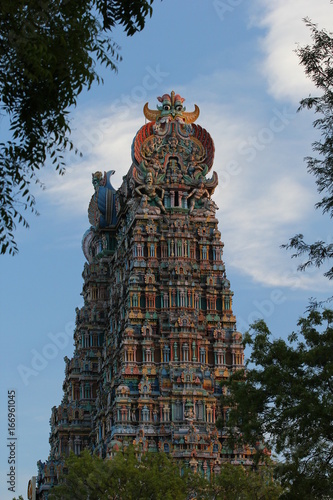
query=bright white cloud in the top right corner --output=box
[254,0,333,102]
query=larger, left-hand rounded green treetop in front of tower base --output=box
[50,447,186,500]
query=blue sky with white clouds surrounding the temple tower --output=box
[0,0,333,500]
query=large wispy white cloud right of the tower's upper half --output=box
[201,107,329,291]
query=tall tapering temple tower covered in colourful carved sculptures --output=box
[31,92,250,498]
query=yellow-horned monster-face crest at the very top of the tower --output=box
[143,91,200,124]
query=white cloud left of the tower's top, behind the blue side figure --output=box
[38,106,144,217]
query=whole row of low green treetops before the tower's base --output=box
[41,446,281,500]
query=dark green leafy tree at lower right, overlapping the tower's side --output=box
[222,310,333,499]
